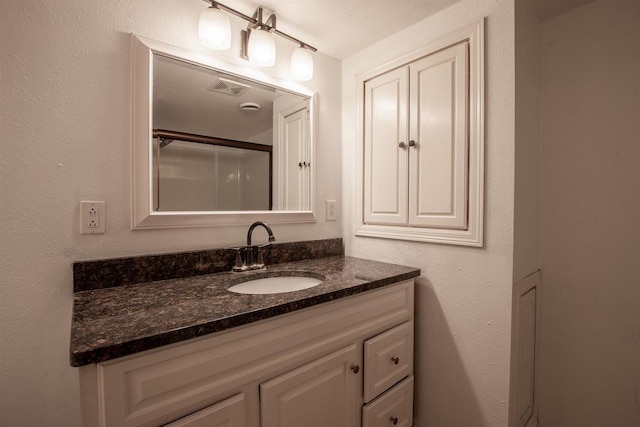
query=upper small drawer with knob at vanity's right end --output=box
[364,321,413,402]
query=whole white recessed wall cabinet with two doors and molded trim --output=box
[356,22,484,246]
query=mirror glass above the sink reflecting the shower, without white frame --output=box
[152,54,310,211]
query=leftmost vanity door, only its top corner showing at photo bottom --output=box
[164,393,247,427]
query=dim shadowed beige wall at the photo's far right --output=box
[539,0,640,427]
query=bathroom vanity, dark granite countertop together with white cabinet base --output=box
[71,242,420,427]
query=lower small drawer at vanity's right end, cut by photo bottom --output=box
[362,377,413,427]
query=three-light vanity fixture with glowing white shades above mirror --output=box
[199,0,317,81]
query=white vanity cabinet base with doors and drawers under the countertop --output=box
[80,280,414,427]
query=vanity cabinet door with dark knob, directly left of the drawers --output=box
[260,345,362,427]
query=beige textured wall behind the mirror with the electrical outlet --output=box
[0,0,341,427]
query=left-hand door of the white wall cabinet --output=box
[363,67,408,225]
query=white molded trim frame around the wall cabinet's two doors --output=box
[354,19,484,247]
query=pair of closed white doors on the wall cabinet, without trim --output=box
[364,43,468,228]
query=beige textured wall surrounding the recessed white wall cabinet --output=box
[342,0,515,427]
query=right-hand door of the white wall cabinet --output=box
[409,43,469,229]
